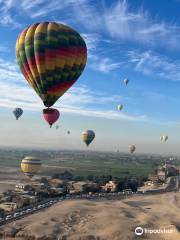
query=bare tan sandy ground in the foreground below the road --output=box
[0,192,180,240]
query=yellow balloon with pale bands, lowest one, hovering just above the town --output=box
[21,156,41,178]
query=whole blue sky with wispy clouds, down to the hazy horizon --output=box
[0,0,180,154]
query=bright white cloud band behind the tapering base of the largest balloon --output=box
[0,56,146,121]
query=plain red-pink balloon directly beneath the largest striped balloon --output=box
[43,108,60,127]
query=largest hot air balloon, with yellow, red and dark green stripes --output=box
[16,22,87,107]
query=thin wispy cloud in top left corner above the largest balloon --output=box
[0,0,85,28]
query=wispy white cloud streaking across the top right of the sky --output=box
[71,0,180,49]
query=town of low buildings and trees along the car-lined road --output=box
[0,152,180,224]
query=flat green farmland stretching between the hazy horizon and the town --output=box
[0,146,179,177]
